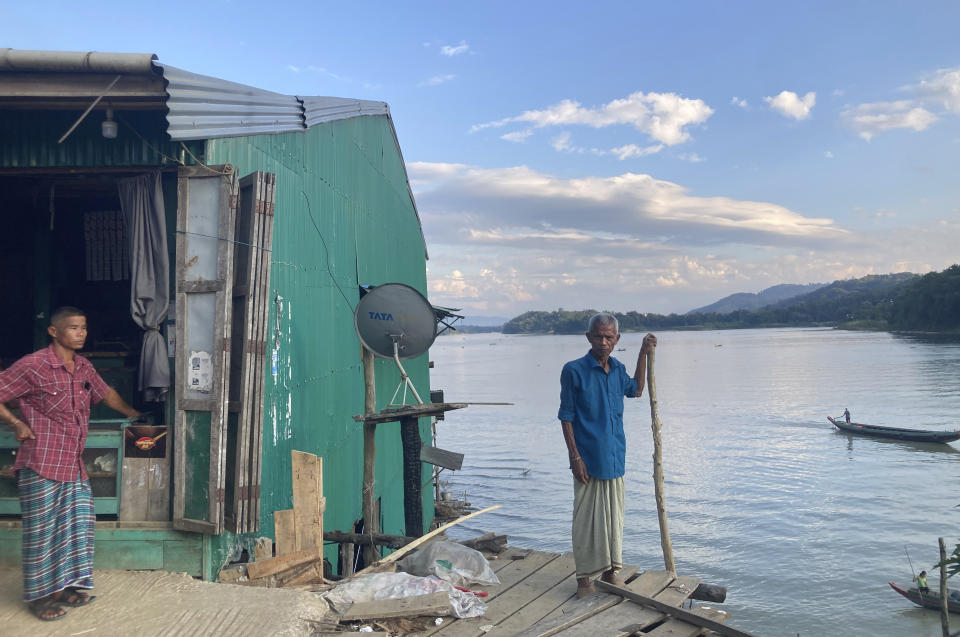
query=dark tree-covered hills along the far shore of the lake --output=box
[502,265,960,334]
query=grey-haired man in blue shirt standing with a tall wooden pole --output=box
[557,313,657,597]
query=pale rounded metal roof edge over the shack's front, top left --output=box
[0,48,157,73]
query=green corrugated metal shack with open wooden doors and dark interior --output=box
[0,49,433,579]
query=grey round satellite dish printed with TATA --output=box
[353,283,437,359]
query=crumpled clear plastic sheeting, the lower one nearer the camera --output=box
[321,573,487,618]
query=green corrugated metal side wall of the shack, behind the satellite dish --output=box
[207,116,433,568]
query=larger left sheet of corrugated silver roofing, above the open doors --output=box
[156,64,306,140]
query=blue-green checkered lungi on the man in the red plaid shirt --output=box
[17,469,94,602]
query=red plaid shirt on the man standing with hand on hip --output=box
[0,345,110,482]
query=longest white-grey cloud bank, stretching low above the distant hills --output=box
[408,161,846,245]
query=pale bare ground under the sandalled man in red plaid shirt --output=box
[0,567,335,637]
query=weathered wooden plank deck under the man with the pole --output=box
[356,547,746,637]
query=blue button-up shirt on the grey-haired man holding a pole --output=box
[557,352,638,480]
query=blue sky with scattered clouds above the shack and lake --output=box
[7,0,960,317]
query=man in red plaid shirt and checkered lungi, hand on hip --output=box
[0,307,140,621]
